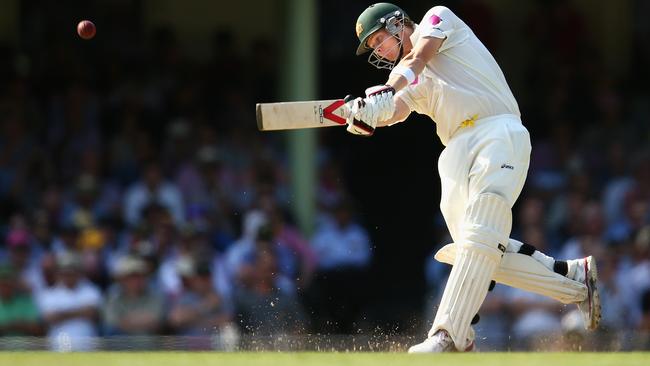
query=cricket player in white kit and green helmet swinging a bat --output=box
[347,3,600,353]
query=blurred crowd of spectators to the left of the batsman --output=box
[0,17,371,350]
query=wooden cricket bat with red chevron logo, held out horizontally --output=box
[256,99,351,131]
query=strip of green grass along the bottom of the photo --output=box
[0,352,650,366]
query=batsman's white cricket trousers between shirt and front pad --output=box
[438,114,531,242]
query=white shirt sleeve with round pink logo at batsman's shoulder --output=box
[418,6,470,53]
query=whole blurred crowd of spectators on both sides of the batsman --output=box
[0,1,650,350]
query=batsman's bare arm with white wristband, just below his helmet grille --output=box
[386,37,445,91]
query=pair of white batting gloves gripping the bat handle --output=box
[347,85,395,136]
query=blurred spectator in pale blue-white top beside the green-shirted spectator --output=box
[38,252,102,351]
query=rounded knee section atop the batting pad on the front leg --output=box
[460,193,512,257]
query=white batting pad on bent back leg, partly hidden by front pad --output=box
[435,243,587,304]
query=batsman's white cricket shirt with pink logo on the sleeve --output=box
[397,6,520,146]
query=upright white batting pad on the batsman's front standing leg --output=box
[429,193,512,351]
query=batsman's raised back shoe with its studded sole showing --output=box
[574,256,601,330]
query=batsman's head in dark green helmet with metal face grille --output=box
[355,3,413,70]
